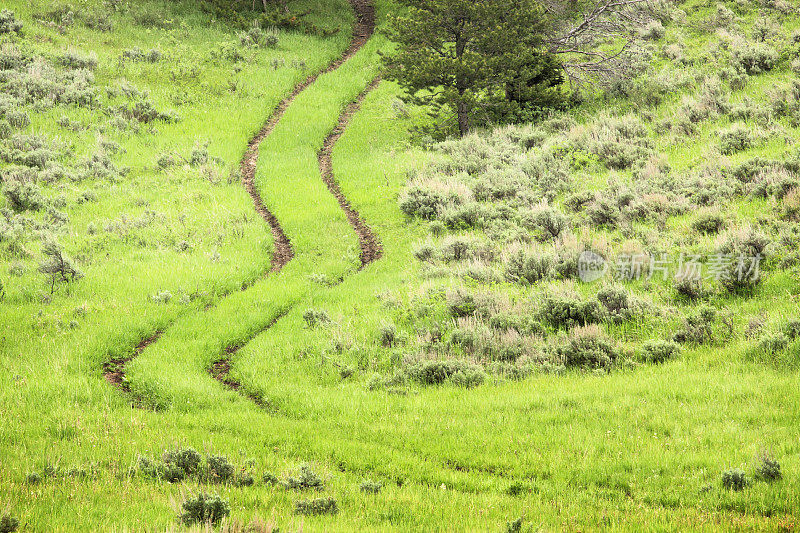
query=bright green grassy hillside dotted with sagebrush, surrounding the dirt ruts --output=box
[0,0,800,531]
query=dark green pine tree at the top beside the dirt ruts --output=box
[384,0,563,135]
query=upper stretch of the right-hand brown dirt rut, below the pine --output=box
[318,78,383,268]
